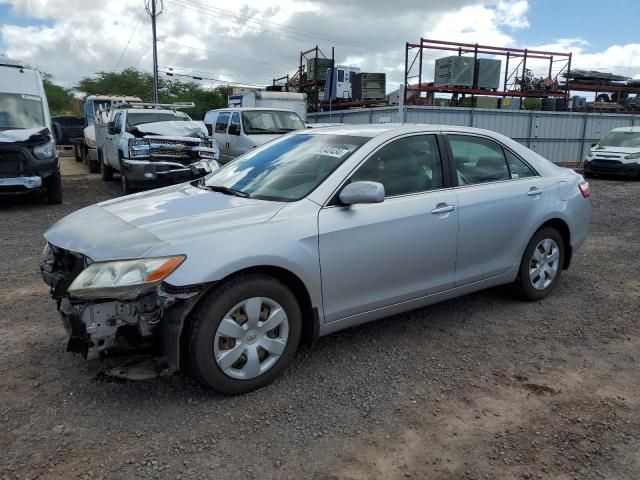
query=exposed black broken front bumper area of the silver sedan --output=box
[40,245,207,379]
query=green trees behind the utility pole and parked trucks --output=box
[75,68,227,120]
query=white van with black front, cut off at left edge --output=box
[0,57,62,203]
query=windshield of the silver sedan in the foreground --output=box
[204,134,369,202]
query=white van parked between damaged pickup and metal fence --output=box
[204,107,305,163]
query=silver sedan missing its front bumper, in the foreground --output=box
[41,124,591,394]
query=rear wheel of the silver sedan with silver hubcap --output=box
[513,227,564,301]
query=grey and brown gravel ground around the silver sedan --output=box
[0,159,640,480]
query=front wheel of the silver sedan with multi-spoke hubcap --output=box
[187,274,302,395]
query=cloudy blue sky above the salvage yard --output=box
[0,0,640,89]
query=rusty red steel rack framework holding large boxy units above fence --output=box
[404,38,571,104]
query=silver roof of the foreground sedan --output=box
[294,123,510,138]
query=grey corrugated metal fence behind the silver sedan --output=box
[308,106,640,163]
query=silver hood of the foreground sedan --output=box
[44,183,285,261]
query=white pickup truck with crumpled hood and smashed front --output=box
[96,103,220,194]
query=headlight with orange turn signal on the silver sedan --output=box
[69,255,186,299]
